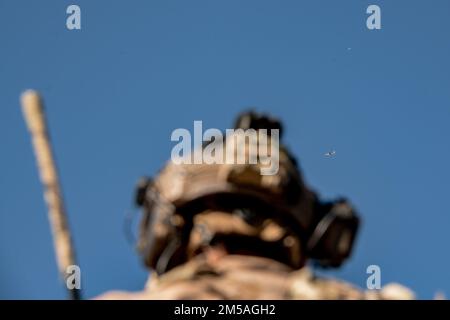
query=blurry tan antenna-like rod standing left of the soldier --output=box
[21,90,79,299]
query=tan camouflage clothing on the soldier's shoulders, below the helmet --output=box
[97,249,415,300]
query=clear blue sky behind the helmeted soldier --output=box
[0,0,450,299]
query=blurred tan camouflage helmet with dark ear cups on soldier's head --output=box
[136,112,359,273]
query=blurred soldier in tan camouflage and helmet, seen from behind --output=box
[99,112,413,299]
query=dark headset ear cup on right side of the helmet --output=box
[308,200,359,268]
